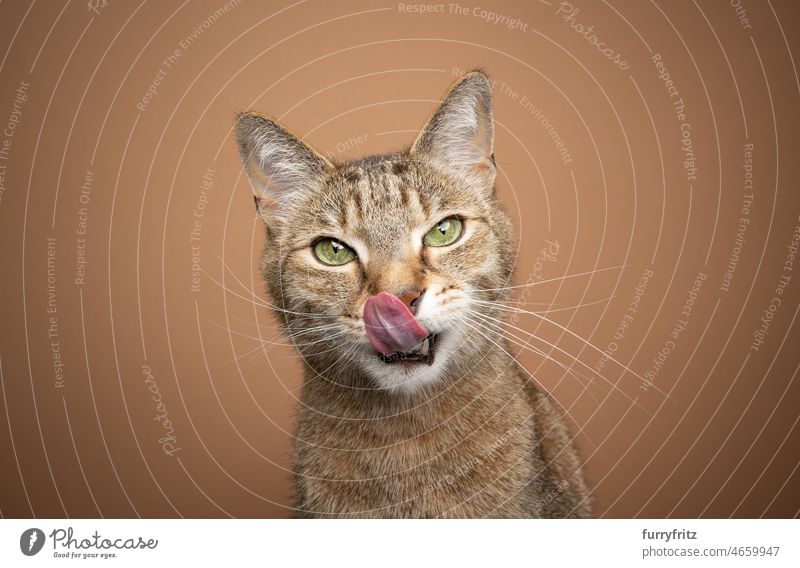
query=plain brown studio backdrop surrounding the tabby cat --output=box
[0,0,800,517]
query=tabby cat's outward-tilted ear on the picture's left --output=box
[236,112,333,220]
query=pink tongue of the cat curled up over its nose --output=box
[364,292,428,355]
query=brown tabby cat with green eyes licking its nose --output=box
[236,71,591,518]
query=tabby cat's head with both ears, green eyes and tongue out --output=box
[237,72,513,391]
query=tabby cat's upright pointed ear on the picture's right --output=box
[411,71,495,187]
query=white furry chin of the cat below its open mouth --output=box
[364,333,456,394]
